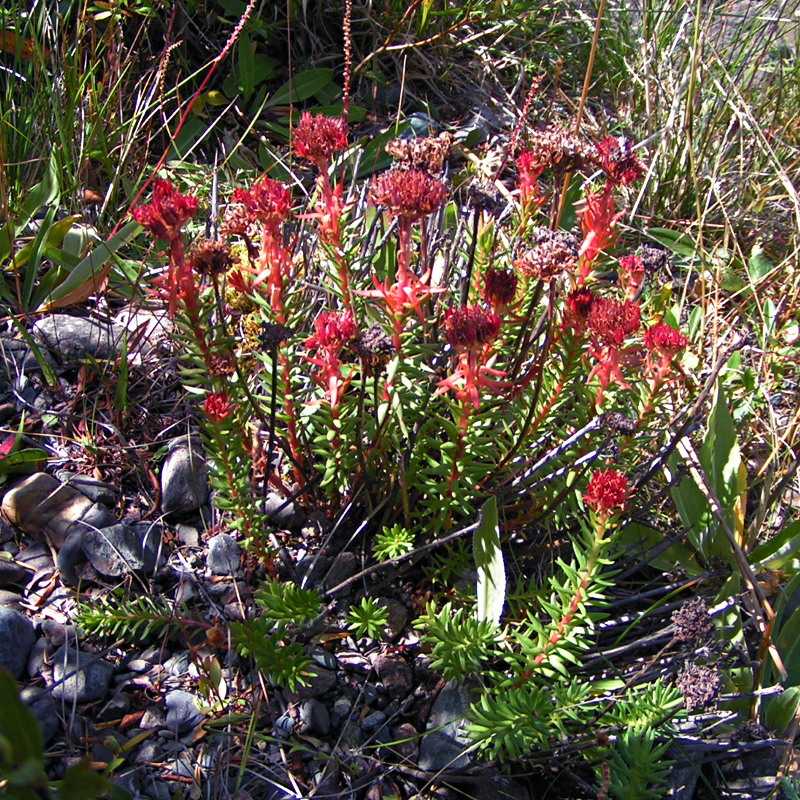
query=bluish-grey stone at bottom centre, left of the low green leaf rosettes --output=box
[419,678,476,772]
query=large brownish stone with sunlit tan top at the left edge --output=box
[2,472,117,548]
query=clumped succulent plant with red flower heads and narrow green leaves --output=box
[134,109,700,772]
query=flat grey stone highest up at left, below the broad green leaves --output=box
[32,314,122,362]
